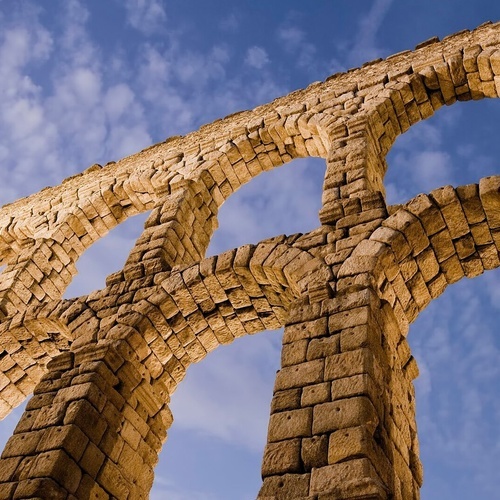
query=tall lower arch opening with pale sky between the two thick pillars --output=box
[151,331,281,500]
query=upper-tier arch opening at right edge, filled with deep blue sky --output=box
[384,99,500,205]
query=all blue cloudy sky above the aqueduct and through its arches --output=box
[0,0,500,500]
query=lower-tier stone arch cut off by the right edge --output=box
[339,176,500,332]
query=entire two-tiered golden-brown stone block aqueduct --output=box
[0,23,500,500]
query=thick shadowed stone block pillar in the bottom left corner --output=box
[0,332,172,499]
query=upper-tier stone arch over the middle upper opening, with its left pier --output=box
[123,109,333,275]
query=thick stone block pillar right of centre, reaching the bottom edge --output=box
[259,282,422,500]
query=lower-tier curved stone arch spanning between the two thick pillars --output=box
[107,240,334,393]
